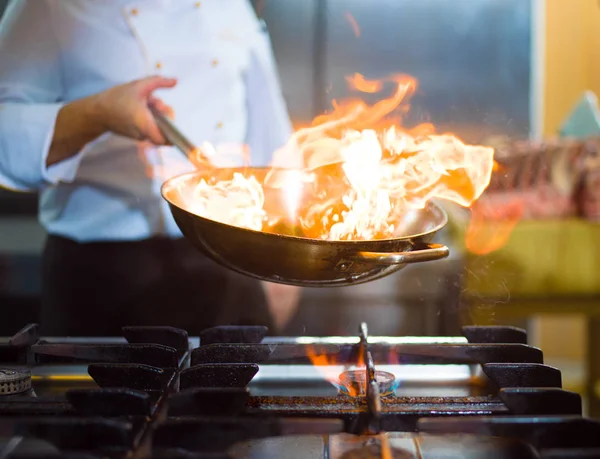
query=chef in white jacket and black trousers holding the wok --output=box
[0,0,299,336]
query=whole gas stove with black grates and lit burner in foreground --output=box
[0,324,600,459]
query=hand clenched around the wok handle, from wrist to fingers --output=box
[93,76,177,145]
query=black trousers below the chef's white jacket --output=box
[40,236,273,336]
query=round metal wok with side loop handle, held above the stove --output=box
[161,168,449,287]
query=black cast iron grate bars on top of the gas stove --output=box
[0,325,600,459]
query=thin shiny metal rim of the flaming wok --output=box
[160,167,448,247]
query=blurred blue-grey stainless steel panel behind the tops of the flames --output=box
[263,0,535,142]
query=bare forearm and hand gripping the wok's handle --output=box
[46,76,177,167]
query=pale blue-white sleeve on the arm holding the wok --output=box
[0,0,81,191]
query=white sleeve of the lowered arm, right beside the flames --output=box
[241,4,293,166]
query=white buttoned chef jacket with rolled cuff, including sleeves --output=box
[0,0,291,242]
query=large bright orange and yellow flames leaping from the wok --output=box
[186,74,497,240]
